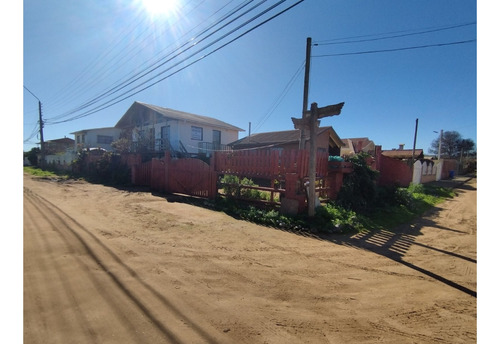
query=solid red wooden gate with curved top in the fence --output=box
[165,157,217,198]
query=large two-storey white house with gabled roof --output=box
[115,102,244,155]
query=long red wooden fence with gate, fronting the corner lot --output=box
[132,149,352,211]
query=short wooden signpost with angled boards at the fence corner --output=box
[292,103,344,217]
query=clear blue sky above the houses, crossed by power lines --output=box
[22,0,477,153]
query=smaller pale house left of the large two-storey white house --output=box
[71,127,121,151]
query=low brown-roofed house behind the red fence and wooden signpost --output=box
[229,127,344,156]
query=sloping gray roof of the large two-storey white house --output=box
[116,101,244,131]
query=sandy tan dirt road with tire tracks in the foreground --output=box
[23,175,477,344]
